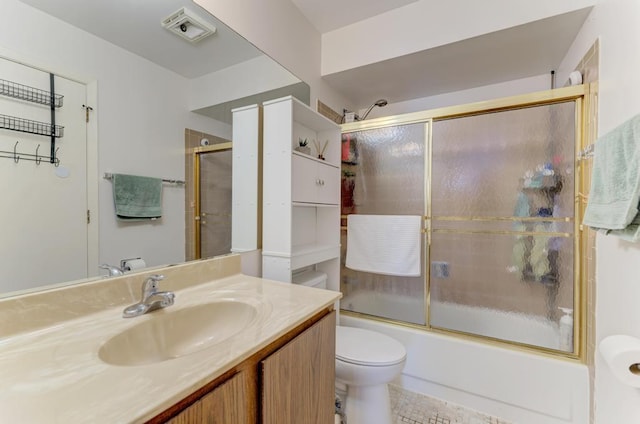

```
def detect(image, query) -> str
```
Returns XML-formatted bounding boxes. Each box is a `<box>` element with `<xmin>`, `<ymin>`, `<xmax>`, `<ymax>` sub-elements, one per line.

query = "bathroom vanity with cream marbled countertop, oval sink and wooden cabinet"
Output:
<box><xmin>0</xmin><ymin>256</ymin><xmax>340</xmax><ymax>424</ymax></box>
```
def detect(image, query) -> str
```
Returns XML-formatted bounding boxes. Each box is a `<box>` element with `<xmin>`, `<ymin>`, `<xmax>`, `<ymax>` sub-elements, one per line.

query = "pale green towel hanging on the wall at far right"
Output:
<box><xmin>583</xmin><ymin>115</ymin><xmax>640</xmax><ymax>241</ymax></box>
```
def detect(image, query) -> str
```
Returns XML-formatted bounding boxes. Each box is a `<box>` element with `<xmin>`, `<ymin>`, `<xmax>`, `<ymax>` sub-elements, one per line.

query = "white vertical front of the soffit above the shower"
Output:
<box><xmin>322</xmin><ymin>0</ymin><xmax>596</xmax><ymax>75</ymax></box>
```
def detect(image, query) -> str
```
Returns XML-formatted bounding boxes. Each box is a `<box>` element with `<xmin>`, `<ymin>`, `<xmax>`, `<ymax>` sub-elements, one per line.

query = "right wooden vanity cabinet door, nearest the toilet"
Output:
<box><xmin>261</xmin><ymin>311</ymin><xmax>336</xmax><ymax>424</ymax></box>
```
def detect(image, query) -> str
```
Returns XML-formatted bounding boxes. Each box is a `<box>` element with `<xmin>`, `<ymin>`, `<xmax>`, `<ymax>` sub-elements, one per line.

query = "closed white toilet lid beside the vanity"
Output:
<box><xmin>336</xmin><ymin>326</ymin><xmax>407</xmax><ymax>367</ymax></box>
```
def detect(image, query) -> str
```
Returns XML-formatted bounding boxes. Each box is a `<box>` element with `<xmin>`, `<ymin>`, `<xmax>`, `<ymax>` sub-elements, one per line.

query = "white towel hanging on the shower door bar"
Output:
<box><xmin>346</xmin><ymin>215</ymin><xmax>422</xmax><ymax>277</ymax></box>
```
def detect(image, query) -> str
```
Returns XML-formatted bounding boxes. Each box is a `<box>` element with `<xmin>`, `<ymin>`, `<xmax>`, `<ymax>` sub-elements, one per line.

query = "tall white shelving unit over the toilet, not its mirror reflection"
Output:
<box><xmin>262</xmin><ymin>96</ymin><xmax>341</xmax><ymax>290</ymax></box>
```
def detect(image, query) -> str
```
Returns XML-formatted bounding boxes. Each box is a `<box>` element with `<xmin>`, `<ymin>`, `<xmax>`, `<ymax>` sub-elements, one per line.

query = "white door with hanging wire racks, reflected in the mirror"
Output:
<box><xmin>0</xmin><ymin>59</ymin><xmax>88</xmax><ymax>293</ymax></box>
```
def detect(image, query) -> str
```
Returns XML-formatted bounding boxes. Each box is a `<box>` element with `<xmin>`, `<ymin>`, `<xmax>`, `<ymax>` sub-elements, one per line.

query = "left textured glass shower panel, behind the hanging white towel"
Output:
<box><xmin>340</xmin><ymin>122</ymin><xmax>428</xmax><ymax>325</ymax></box>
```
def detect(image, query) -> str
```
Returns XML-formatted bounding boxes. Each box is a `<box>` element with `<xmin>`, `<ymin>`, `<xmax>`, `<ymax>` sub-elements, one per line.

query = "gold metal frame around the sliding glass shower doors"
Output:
<box><xmin>340</xmin><ymin>85</ymin><xmax>591</xmax><ymax>362</ymax></box>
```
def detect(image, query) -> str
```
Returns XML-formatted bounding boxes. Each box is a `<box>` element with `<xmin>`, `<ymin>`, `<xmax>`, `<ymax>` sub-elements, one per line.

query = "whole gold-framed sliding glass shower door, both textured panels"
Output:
<box><xmin>341</xmin><ymin>87</ymin><xmax>584</xmax><ymax>357</ymax></box>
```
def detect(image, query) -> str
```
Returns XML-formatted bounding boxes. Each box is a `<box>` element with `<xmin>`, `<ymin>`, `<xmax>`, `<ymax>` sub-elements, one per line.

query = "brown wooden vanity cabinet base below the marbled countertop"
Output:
<box><xmin>161</xmin><ymin>312</ymin><xmax>336</xmax><ymax>424</ymax></box>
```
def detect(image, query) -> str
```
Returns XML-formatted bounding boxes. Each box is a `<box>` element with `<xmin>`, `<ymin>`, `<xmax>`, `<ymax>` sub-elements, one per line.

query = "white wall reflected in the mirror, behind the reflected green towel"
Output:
<box><xmin>0</xmin><ymin>0</ymin><xmax>231</xmax><ymax>274</ymax></box>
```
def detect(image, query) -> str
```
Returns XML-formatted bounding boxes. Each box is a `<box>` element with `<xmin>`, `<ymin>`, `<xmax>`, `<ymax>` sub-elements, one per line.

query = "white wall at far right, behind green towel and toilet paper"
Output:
<box><xmin>558</xmin><ymin>0</ymin><xmax>640</xmax><ymax>424</ymax></box>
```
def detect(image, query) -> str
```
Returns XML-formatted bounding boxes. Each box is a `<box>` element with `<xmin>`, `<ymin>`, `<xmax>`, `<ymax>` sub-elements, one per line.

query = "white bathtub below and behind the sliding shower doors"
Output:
<box><xmin>340</xmin><ymin>293</ymin><xmax>589</xmax><ymax>424</ymax></box>
